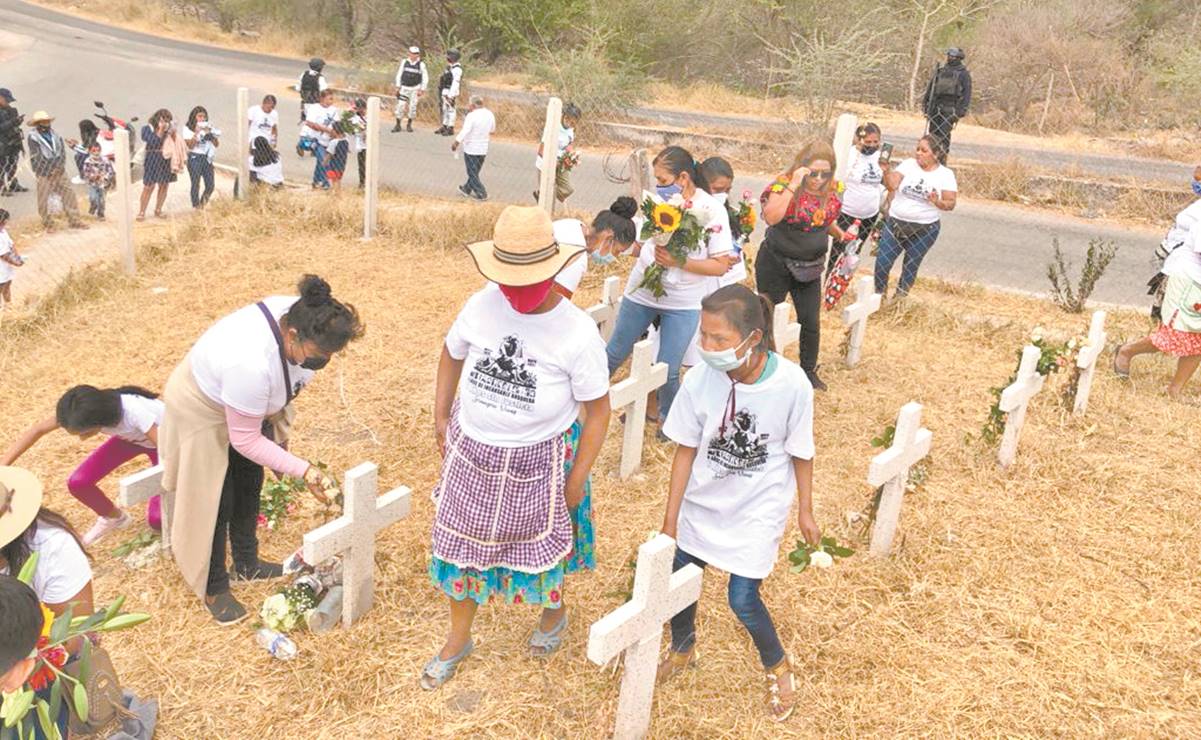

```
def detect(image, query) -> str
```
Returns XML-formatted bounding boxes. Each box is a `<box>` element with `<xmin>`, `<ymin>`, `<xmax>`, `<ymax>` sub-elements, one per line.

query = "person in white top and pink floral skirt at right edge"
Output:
<box><xmin>1113</xmin><ymin>227</ymin><xmax>1201</xmax><ymax>400</ymax></box>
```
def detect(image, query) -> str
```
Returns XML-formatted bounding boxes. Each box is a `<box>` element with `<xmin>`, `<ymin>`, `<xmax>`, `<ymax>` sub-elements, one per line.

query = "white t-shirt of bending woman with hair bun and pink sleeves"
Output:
<box><xmin>189</xmin><ymin>296</ymin><xmax>315</xmax><ymax>417</ymax></box>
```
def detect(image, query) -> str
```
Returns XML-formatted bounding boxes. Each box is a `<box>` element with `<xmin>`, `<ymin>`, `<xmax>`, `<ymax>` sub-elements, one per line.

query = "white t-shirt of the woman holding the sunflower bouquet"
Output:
<box><xmin>626</xmin><ymin>190</ymin><xmax>734</xmax><ymax>310</ymax></box>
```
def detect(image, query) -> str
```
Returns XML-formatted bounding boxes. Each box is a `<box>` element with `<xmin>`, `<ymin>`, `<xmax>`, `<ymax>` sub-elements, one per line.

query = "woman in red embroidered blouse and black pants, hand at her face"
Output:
<box><xmin>754</xmin><ymin>141</ymin><xmax>854</xmax><ymax>390</ymax></box>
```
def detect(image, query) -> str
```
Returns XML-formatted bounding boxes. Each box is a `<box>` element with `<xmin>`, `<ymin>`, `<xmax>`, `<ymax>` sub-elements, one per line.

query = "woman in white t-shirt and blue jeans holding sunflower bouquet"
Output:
<box><xmin>605</xmin><ymin>147</ymin><xmax>740</xmax><ymax>434</ymax></box>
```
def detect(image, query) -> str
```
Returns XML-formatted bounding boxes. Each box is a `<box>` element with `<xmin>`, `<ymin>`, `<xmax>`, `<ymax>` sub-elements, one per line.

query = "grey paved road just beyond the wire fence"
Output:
<box><xmin>0</xmin><ymin>0</ymin><xmax>1158</xmax><ymax>305</ymax></box>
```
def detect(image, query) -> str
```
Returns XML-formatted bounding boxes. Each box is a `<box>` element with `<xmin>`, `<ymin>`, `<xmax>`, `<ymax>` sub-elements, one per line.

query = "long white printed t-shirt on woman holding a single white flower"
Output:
<box><xmin>663</xmin><ymin>356</ymin><xmax>813</xmax><ymax>578</ymax></box>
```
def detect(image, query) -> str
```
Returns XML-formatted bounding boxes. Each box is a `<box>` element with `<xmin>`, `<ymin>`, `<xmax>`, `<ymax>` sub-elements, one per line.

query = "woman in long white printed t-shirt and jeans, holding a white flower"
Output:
<box><xmin>658</xmin><ymin>285</ymin><xmax>821</xmax><ymax>721</ymax></box>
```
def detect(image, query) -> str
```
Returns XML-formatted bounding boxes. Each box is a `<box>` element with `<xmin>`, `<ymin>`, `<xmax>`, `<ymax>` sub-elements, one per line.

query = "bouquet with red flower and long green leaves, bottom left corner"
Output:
<box><xmin>0</xmin><ymin>553</ymin><xmax>150</xmax><ymax>740</ymax></box>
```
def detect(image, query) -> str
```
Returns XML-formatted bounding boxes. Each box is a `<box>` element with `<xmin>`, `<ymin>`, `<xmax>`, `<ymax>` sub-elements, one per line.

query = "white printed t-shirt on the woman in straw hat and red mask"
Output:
<box><xmin>446</xmin><ymin>285</ymin><xmax>609</xmax><ymax>447</ymax></box>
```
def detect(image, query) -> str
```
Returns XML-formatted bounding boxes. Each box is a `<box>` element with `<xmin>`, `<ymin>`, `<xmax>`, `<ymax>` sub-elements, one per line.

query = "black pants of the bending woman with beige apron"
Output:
<box><xmin>205</xmin><ymin>447</ymin><xmax>263</xmax><ymax>596</ymax></box>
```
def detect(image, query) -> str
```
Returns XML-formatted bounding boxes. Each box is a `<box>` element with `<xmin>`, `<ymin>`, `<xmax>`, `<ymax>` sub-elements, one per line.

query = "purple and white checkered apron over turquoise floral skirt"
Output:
<box><xmin>434</xmin><ymin>408</ymin><xmax>572</xmax><ymax>573</ymax></box>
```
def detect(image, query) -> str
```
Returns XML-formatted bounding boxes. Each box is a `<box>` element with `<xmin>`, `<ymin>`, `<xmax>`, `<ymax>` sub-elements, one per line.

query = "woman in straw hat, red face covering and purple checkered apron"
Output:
<box><xmin>420</xmin><ymin>205</ymin><xmax>609</xmax><ymax>690</ymax></box>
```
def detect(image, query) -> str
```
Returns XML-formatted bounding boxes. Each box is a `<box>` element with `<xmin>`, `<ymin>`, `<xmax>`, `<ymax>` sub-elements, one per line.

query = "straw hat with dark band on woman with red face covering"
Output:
<box><xmin>467</xmin><ymin>205</ymin><xmax>584</xmax><ymax>287</ymax></box>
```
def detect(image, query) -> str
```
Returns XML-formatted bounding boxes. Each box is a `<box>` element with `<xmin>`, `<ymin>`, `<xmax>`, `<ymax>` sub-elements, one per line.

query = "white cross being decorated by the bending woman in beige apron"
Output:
<box><xmin>304</xmin><ymin>463</ymin><xmax>412</xmax><ymax>627</ymax></box>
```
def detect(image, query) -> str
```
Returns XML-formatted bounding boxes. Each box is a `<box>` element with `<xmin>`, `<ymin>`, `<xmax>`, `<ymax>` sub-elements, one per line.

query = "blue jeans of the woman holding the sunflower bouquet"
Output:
<box><xmin>604</xmin><ymin>298</ymin><xmax>700</xmax><ymax>424</ymax></box>
